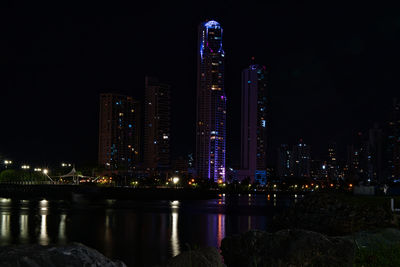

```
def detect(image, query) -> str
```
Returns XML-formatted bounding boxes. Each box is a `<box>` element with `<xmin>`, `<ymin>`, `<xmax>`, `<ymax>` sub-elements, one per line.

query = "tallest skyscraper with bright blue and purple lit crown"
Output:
<box><xmin>196</xmin><ymin>20</ymin><xmax>226</xmax><ymax>182</ymax></box>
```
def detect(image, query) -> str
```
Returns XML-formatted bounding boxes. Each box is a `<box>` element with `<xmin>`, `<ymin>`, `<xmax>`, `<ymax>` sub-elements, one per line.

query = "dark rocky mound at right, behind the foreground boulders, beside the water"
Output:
<box><xmin>272</xmin><ymin>193</ymin><xmax>398</xmax><ymax>236</ymax></box>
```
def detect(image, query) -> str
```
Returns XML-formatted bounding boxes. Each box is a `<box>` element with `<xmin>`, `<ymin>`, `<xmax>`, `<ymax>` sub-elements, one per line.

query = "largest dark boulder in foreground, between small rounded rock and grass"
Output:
<box><xmin>221</xmin><ymin>230</ymin><xmax>355</xmax><ymax>267</ymax></box>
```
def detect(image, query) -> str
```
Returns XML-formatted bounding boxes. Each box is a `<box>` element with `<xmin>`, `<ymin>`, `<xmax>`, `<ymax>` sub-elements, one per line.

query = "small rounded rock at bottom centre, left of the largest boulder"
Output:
<box><xmin>167</xmin><ymin>247</ymin><xmax>225</xmax><ymax>267</ymax></box>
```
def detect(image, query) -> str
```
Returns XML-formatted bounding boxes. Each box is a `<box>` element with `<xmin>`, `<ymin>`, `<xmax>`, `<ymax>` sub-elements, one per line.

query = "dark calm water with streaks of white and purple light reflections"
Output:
<box><xmin>0</xmin><ymin>194</ymin><xmax>296</xmax><ymax>266</ymax></box>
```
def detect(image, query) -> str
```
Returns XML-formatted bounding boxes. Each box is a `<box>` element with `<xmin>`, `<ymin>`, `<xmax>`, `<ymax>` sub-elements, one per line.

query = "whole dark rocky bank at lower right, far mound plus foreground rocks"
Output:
<box><xmin>167</xmin><ymin>193</ymin><xmax>400</xmax><ymax>267</ymax></box>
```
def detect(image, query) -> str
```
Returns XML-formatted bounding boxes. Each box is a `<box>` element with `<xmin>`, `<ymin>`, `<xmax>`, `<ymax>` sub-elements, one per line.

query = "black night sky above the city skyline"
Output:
<box><xmin>0</xmin><ymin>1</ymin><xmax>400</xmax><ymax>168</ymax></box>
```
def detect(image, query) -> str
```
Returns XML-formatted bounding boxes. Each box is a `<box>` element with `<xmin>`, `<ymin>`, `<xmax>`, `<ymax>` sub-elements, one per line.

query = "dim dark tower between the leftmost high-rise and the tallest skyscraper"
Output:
<box><xmin>144</xmin><ymin>76</ymin><xmax>171</xmax><ymax>177</ymax></box>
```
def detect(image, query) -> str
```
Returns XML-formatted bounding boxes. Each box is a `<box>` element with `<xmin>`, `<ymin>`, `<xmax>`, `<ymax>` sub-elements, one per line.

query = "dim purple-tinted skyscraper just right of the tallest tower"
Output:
<box><xmin>240</xmin><ymin>62</ymin><xmax>267</xmax><ymax>184</ymax></box>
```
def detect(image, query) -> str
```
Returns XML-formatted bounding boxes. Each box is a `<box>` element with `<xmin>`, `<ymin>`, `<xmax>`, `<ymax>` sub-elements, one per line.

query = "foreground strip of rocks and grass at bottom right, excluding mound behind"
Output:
<box><xmin>166</xmin><ymin>228</ymin><xmax>400</xmax><ymax>267</ymax></box>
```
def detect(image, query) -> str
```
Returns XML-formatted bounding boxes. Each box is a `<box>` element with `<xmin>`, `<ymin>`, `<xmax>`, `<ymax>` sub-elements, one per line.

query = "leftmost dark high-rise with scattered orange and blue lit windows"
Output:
<box><xmin>98</xmin><ymin>93</ymin><xmax>140</xmax><ymax>172</ymax></box>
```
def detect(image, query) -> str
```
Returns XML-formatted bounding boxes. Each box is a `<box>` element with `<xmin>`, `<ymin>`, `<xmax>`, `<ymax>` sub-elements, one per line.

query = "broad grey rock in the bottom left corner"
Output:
<box><xmin>0</xmin><ymin>243</ymin><xmax>126</xmax><ymax>267</ymax></box>
